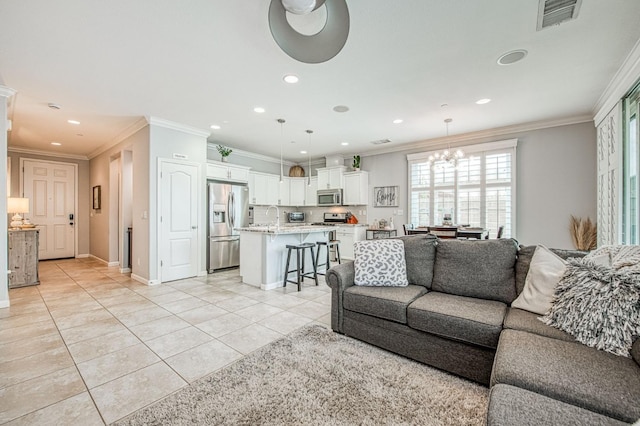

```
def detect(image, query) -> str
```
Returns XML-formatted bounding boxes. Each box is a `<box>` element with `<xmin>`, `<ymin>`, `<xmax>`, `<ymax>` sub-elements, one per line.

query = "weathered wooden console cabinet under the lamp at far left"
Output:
<box><xmin>8</xmin><ymin>229</ymin><xmax>40</xmax><ymax>288</ymax></box>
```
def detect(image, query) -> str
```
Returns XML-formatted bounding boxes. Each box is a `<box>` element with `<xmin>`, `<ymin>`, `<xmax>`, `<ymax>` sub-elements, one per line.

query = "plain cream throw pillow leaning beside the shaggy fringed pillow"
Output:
<box><xmin>511</xmin><ymin>245</ymin><xmax>566</xmax><ymax>315</ymax></box>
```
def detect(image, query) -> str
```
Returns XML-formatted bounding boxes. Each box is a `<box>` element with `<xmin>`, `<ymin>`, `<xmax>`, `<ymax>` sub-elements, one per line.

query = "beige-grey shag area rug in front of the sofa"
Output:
<box><xmin>115</xmin><ymin>325</ymin><xmax>489</xmax><ymax>425</ymax></box>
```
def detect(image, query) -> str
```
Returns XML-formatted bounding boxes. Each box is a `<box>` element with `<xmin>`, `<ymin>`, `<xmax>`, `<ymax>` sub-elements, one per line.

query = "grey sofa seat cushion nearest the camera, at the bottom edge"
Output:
<box><xmin>487</xmin><ymin>384</ymin><xmax>627</xmax><ymax>426</ymax></box>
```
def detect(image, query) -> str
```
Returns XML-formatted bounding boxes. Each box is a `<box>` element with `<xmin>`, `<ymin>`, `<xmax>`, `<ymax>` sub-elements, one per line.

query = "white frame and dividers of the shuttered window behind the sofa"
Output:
<box><xmin>407</xmin><ymin>139</ymin><xmax>518</xmax><ymax>238</ymax></box>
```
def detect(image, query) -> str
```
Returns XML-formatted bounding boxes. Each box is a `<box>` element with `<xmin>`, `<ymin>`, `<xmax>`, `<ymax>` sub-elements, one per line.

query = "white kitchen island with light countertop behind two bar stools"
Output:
<box><xmin>237</xmin><ymin>225</ymin><xmax>335</xmax><ymax>290</ymax></box>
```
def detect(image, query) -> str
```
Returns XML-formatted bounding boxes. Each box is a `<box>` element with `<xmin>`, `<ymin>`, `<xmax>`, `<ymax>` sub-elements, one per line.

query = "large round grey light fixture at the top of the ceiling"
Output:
<box><xmin>269</xmin><ymin>0</ymin><xmax>350</xmax><ymax>64</ymax></box>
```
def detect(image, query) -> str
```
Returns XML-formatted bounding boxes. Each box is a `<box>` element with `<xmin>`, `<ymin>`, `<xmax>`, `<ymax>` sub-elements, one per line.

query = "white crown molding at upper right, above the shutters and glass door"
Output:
<box><xmin>593</xmin><ymin>40</ymin><xmax>640</xmax><ymax>125</ymax></box>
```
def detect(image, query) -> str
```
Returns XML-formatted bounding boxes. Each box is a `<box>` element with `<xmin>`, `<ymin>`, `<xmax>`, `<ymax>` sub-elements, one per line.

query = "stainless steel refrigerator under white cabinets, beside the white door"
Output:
<box><xmin>207</xmin><ymin>182</ymin><xmax>249</xmax><ymax>273</ymax></box>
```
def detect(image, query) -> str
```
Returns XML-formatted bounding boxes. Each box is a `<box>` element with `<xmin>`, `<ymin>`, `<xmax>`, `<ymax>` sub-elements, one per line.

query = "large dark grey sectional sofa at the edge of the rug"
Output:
<box><xmin>326</xmin><ymin>235</ymin><xmax>640</xmax><ymax>425</ymax></box>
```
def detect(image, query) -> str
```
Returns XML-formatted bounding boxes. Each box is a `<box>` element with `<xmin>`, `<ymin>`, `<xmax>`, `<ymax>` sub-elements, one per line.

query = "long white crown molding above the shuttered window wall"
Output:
<box><xmin>360</xmin><ymin>114</ymin><xmax>593</xmax><ymax>157</ymax></box>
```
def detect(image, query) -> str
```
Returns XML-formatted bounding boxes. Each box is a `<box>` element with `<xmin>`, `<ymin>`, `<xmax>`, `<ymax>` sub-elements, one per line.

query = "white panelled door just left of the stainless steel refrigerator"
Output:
<box><xmin>159</xmin><ymin>162</ymin><xmax>199</xmax><ymax>282</ymax></box>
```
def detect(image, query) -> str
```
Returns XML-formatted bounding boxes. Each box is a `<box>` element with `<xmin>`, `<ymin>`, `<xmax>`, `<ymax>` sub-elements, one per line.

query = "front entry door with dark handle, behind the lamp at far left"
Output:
<box><xmin>23</xmin><ymin>160</ymin><xmax>76</xmax><ymax>259</ymax></box>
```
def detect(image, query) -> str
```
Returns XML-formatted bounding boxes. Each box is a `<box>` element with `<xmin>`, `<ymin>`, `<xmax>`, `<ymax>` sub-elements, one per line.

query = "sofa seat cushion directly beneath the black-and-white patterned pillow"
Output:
<box><xmin>343</xmin><ymin>285</ymin><xmax>427</xmax><ymax>324</ymax></box>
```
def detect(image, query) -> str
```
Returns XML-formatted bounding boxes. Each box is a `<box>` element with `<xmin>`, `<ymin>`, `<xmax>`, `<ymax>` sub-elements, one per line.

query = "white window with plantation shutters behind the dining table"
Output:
<box><xmin>407</xmin><ymin>139</ymin><xmax>517</xmax><ymax>238</ymax></box>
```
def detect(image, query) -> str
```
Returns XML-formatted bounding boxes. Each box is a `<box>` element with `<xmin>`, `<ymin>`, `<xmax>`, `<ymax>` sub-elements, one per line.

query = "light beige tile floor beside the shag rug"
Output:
<box><xmin>0</xmin><ymin>259</ymin><xmax>331</xmax><ymax>426</ymax></box>
